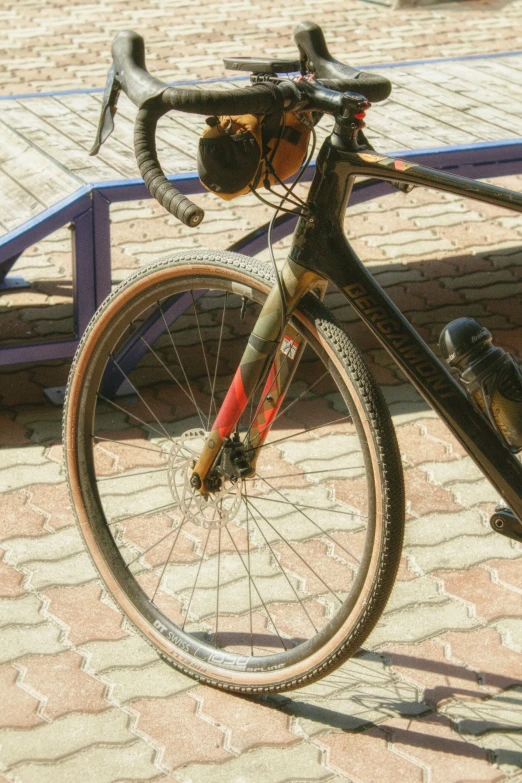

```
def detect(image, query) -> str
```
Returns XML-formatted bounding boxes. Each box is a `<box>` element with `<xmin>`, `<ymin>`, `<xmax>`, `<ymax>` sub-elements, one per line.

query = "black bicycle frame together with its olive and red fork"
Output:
<box><xmin>195</xmin><ymin>135</ymin><xmax>522</xmax><ymax>521</ymax></box>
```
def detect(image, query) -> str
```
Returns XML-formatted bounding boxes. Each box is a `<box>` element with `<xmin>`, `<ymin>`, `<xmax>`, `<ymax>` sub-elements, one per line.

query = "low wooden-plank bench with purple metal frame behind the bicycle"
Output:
<box><xmin>0</xmin><ymin>52</ymin><xmax>522</xmax><ymax>365</ymax></box>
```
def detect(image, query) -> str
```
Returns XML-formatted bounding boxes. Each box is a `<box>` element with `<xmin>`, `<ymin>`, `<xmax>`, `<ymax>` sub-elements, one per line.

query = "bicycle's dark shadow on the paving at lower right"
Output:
<box><xmin>247</xmin><ymin>650</ymin><xmax>522</xmax><ymax>768</ymax></box>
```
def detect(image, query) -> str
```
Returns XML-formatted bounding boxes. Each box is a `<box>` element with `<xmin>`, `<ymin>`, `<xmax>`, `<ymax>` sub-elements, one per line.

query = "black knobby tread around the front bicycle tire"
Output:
<box><xmin>62</xmin><ymin>250</ymin><xmax>404</xmax><ymax>695</ymax></box>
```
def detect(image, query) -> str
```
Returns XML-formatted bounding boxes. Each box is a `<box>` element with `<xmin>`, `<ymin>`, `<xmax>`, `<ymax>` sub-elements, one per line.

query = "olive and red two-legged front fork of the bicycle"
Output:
<box><xmin>189</xmin><ymin>259</ymin><xmax>326</xmax><ymax>491</ymax></box>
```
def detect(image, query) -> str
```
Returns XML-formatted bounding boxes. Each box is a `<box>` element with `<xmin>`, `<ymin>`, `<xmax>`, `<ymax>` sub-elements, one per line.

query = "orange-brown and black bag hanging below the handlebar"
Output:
<box><xmin>198</xmin><ymin>112</ymin><xmax>313</xmax><ymax>201</ymax></box>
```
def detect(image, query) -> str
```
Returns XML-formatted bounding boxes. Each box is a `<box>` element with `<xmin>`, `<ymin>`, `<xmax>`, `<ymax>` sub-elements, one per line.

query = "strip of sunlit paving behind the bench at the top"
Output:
<box><xmin>0</xmin><ymin>0</ymin><xmax>522</xmax><ymax>94</ymax></box>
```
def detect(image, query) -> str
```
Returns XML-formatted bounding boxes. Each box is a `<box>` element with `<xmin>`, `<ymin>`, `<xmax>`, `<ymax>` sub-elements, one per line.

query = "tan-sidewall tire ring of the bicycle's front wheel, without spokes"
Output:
<box><xmin>64</xmin><ymin>251</ymin><xmax>404</xmax><ymax>693</ymax></box>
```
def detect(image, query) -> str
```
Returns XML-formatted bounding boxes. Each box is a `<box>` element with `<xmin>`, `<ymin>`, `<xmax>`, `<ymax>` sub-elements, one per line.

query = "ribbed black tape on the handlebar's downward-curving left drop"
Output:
<box><xmin>134</xmin><ymin>100</ymin><xmax>205</xmax><ymax>227</ymax></box>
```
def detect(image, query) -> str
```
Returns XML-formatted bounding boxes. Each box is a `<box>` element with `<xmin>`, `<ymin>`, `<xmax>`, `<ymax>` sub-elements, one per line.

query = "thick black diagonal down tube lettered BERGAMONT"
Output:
<box><xmin>316</xmin><ymin>235</ymin><xmax>522</xmax><ymax>520</ymax></box>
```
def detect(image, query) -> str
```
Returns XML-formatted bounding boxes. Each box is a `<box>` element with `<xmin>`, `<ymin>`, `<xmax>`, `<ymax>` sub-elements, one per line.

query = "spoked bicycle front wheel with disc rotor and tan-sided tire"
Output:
<box><xmin>64</xmin><ymin>251</ymin><xmax>404</xmax><ymax>693</ymax></box>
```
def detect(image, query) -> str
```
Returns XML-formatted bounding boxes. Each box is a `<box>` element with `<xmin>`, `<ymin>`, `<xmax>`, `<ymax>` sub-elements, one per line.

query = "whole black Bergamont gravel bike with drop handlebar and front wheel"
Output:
<box><xmin>64</xmin><ymin>23</ymin><xmax>522</xmax><ymax>694</ymax></box>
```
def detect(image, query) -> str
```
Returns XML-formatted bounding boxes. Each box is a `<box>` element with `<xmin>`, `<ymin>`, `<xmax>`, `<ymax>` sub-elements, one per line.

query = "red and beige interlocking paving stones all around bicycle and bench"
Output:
<box><xmin>0</xmin><ymin>0</ymin><xmax>522</xmax><ymax>783</ymax></box>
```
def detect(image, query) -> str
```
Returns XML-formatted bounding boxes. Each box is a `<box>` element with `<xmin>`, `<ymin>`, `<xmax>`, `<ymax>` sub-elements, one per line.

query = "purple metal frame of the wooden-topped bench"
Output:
<box><xmin>0</xmin><ymin>46</ymin><xmax>522</xmax><ymax>366</ymax></box>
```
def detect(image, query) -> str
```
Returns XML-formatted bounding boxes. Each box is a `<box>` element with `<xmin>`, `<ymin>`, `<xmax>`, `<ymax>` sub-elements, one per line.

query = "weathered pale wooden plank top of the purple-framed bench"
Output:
<box><xmin>0</xmin><ymin>55</ymin><xmax>522</xmax><ymax>234</ymax></box>
